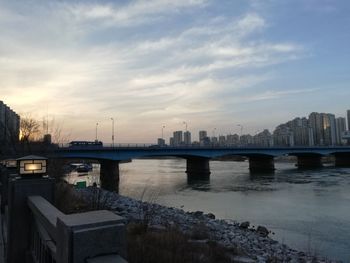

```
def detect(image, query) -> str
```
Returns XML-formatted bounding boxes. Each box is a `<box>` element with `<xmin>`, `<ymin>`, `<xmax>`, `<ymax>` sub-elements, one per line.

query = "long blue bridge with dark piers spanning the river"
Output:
<box><xmin>52</xmin><ymin>146</ymin><xmax>350</xmax><ymax>190</ymax></box>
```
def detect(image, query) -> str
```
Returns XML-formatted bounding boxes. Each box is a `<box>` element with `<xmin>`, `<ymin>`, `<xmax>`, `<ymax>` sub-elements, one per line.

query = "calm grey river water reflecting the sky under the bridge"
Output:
<box><xmin>67</xmin><ymin>159</ymin><xmax>350</xmax><ymax>262</ymax></box>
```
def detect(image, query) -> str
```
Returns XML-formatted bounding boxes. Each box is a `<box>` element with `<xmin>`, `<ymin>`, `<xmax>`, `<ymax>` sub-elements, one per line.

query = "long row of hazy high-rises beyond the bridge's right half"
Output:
<box><xmin>164</xmin><ymin>110</ymin><xmax>350</xmax><ymax>147</ymax></box>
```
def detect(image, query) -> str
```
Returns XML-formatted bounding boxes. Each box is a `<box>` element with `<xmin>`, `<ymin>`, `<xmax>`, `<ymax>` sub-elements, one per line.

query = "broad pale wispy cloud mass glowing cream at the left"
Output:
<box><xmin>0</xmin><ymin>0</ymin><xmax>304</xmax><ymax>140</ymax></box>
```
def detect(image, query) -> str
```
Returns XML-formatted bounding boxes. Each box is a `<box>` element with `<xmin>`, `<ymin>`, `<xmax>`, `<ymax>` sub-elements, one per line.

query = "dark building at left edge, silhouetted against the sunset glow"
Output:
<box><xmin>0</xmin><ymin>101</ymin><xmax>20</xmax><ymax>145</ymax></box>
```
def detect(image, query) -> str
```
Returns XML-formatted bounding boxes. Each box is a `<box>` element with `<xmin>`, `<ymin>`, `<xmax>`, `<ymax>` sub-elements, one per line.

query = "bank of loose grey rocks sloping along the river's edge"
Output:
<box><xmin>79</xmin><ymin>187</ymin><xmax>339</xmax><ymax>263</ymax></box>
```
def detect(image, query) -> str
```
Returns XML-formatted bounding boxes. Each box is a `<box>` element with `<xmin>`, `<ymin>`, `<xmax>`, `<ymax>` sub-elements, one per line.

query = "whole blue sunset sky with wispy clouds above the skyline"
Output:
<box><xmin>0</xmin><ymin>0</ymin><xmax>350</xmax><ymax>143</ymax></box>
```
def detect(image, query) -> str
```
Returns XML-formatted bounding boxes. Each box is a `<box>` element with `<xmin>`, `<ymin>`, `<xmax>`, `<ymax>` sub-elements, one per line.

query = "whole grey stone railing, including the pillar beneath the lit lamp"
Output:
<box><xmin>0</xmin><ymin>165</ymin><xmax>126</xmax><ymax>263</ymax></box>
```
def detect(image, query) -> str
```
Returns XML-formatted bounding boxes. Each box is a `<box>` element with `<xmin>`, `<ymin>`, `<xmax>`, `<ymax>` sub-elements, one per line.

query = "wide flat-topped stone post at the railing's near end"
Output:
<box><xmin>56</xmin><ymin>210</ymin><xmax>126</xmax><ymax>263</ymax></box>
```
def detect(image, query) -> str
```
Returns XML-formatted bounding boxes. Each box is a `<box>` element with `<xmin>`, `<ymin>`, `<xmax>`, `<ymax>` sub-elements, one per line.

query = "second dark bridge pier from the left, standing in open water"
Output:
<box><xmin>186</xmin><ymin>157</ymin><xmax>210</xmax><ymax>181</ymax></box>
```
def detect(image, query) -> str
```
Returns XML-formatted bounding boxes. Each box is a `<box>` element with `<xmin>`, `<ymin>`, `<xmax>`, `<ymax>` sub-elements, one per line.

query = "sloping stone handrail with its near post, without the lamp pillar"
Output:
<box><xmin>28</xmin><ymin>196</ymin><xmax>126</xmax><ymax>263</ymax></box>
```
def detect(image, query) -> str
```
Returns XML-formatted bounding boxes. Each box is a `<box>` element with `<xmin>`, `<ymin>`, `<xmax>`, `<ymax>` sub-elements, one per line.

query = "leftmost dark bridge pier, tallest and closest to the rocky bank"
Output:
<box><xmin>99</xmin><ymin>160</ymin><xmax>119</xmax><ymax>191</ymax></box>
